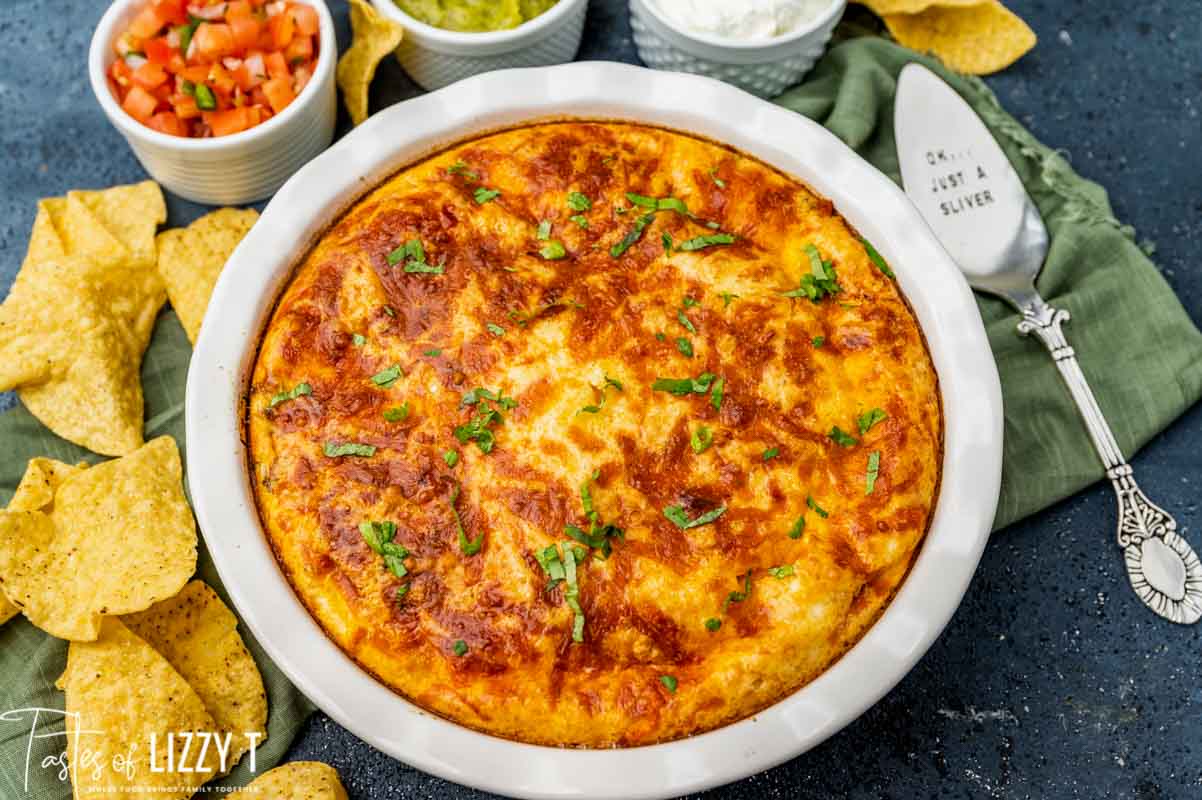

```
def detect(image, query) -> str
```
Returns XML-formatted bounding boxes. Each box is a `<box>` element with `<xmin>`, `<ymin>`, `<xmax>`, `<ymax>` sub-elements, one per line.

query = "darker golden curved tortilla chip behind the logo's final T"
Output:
<box><xmin>121</xmin><ymin>580</ymin><xmax>267</xmax><ymax>769</ymax></box>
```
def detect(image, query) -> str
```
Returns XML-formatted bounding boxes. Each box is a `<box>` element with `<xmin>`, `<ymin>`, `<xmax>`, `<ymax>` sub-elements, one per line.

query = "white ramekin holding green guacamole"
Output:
<box><xmin>371</xmin><ymin>0</ymin><xmax>589</xmax><ymax>91</ymax></box>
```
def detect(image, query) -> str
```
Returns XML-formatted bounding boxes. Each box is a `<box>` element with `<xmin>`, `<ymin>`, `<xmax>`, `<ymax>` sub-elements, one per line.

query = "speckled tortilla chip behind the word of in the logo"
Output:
<box><xmin>58</xmin><ymin>617</ymin><xmax>219</xmax><ymax>800</ymax></box>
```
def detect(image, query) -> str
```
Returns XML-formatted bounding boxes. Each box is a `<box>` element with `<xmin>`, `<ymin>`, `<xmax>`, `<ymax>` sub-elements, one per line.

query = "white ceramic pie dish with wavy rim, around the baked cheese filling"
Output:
<box><xmin>186</xmin><ymin>64</ymin><xmax>1002</xmax><ymax>798</ymax></box>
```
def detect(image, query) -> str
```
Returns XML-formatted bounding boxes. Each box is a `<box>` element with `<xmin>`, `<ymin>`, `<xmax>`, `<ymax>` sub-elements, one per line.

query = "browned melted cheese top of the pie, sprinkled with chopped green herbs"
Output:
<box><xmin>248</xmin><ymin>123</ymin><xmax>941</xmax><ymax>746</ymax></box>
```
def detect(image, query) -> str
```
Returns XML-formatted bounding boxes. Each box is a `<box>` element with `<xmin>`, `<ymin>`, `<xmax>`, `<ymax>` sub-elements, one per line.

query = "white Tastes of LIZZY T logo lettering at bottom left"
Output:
<box><xmin>0</xmin><ymin>708</ymin><xmax>263</xmax><ymax>794</ymax></box>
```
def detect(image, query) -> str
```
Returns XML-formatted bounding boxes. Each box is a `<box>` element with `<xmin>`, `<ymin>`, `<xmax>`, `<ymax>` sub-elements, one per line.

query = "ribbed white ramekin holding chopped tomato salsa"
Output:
<box><xmin>88</xmin><ymin>0</ymin><xmax>338</xmax><ymax>205</ymax></box>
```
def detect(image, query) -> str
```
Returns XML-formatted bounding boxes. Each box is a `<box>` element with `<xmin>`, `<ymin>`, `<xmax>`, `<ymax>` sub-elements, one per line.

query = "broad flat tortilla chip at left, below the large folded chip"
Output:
<box><xmin>0</xmin><ymin>436</ymin><xmax>196</xmax><ymax>641</ymax></box>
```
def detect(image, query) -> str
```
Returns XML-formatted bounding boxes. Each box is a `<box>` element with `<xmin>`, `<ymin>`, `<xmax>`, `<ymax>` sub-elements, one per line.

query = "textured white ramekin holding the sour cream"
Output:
<box><xmin>630</xmin><ymin>0</ymin><xmax>847</xmax><ymax>97</ymax></box>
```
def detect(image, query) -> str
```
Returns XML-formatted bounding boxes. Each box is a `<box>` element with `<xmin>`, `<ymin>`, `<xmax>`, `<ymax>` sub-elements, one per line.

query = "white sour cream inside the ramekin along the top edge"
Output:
<box><xmin>649</xmin><ymin>0</ymin><xmax>832</xmax><ymax>41</ymax></box>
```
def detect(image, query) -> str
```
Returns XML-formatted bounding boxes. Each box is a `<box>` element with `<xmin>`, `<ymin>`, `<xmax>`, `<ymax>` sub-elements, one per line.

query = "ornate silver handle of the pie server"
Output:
<box><xmin>1018</xmin><ymin>297</ymin><xmax>1202</xmax><ymax>625</ymax></box>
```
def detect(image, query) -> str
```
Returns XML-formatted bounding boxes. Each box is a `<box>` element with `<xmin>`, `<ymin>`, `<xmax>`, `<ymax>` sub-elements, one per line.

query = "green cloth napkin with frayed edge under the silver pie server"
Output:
<box><xmin>776</xmin><ymin>38</ymin><xmax>1202</xmax><ymax>530</ymax></box>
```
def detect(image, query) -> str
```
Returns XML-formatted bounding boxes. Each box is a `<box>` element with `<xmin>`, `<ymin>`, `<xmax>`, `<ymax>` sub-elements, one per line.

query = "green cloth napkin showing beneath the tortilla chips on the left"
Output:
<box><xmin>0</xmin><ymin>311</ymin><xmax>314</xmax><ymax>800</ymax></box>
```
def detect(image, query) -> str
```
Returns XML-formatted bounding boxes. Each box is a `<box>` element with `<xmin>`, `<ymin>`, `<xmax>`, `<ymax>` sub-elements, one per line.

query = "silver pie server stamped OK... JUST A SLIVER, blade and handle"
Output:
<box><xmin>894</xmin><ymin>64</ymin><xmax>1202</xmax><ymax>623</ymax></box>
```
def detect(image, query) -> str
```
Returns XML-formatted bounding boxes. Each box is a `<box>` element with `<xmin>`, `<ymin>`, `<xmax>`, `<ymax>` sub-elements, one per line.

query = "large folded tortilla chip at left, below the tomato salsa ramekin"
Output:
<box><xmin>0</xmin><ymin>181</ymin><xmax>167</xmax><ymax>455</ymax></box>
